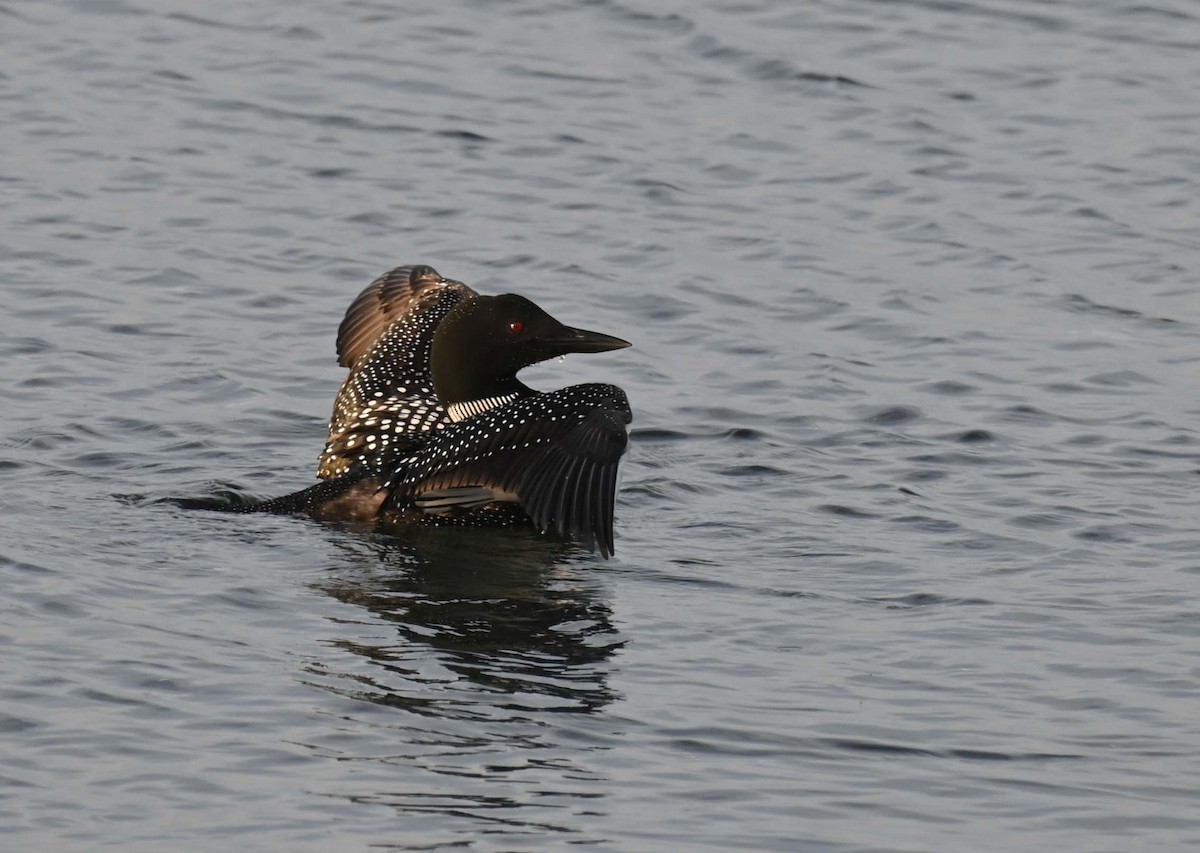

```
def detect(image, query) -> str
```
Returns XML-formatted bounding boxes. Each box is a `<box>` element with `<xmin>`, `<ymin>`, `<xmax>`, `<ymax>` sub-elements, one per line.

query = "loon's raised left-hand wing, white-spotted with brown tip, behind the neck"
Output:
<box><xmin>317</xmin><ymin>266</ymin><xmax>474</xmax><ymax>479</ymax></box>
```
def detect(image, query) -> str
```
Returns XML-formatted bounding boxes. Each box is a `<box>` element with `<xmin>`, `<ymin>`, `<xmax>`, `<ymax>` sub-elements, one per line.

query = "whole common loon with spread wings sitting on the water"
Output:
<box><xmin>234</xmin><ymin>265</ymin><xmax>632</xmax><ymax>557</ymax></box>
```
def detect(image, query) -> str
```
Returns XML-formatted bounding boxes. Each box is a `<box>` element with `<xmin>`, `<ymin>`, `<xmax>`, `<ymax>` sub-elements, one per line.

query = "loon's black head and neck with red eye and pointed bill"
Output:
<box><xmin>430</xmin><ymin>293</ymin><xmax>630</xmax><ymax>407</ymax></box>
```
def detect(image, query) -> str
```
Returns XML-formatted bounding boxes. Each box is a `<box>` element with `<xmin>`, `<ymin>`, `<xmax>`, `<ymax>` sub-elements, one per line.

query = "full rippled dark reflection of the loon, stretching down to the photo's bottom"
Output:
<box><xmin>302</xmin><ymin>525</ymin><xmax>622</xmax><ymax>849</ymax></box>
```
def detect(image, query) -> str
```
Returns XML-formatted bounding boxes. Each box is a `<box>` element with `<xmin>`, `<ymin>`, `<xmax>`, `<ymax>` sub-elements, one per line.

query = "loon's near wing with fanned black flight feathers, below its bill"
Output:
<box><xmin>383</xmin><ymin>384</ymin><xmax>631</xmax><ymax>557</ymax></box>
